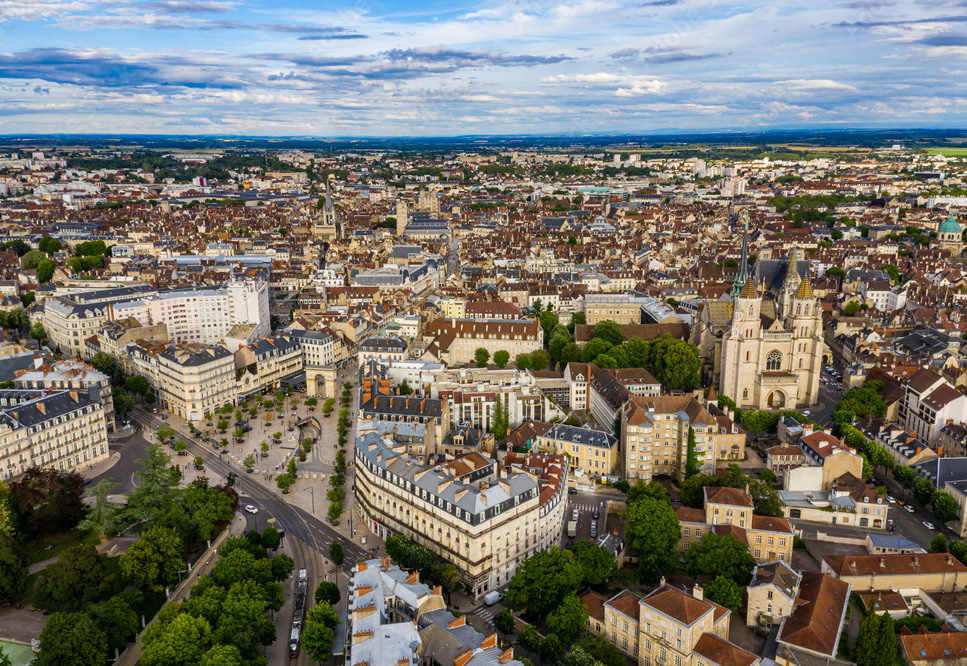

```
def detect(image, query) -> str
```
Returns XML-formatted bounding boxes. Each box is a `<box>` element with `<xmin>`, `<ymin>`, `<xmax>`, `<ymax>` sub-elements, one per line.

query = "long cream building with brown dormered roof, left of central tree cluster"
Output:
<box><xmin>422</xmin><ymin>318</ymin><xmax>544</xmax><ymax>365</ymax></box>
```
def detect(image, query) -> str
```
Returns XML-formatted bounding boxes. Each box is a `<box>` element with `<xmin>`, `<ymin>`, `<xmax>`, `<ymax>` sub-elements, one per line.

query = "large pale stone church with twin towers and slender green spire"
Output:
<box><xmin>693</xmin><ymin>221</ymin><xmax>826</xmax><ymax>410</ymax></box>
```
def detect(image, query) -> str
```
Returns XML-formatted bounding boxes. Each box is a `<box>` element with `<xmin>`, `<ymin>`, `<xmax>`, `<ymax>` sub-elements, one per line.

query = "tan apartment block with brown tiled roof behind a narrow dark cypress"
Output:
<box><xmin>621</xmin><ymin>396</ymin><xmax>745</xmax><ymax>483</ymax></box>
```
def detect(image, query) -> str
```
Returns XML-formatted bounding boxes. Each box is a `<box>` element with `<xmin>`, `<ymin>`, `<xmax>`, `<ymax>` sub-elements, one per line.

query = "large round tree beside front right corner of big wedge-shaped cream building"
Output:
<box><xmin>506</xmin><ymin>546</ymin><xmax>583</xmax><ymax>616</ymax></box>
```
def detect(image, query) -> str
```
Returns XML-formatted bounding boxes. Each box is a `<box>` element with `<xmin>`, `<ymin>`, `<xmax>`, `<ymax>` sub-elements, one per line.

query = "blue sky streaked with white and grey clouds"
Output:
<box><xmin>0</xmin><ymin>0</ymin><xmax>967</xmax><ymax>138</ymax></box>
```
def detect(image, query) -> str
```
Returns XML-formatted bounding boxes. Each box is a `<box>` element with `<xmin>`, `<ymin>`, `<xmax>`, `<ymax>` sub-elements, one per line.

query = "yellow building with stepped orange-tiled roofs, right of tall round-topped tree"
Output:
<box><xmin>675</xmin><ymin>486</ymin><xmax>795</xmax><ymax>562</ymax></box>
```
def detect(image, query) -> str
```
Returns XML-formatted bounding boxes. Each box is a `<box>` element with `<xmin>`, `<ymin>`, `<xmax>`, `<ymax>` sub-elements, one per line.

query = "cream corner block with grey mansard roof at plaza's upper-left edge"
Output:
<box><xmin>158</xmin><ymin>344</ymin><xmax>238</xmax><ymax>422</ymax></box>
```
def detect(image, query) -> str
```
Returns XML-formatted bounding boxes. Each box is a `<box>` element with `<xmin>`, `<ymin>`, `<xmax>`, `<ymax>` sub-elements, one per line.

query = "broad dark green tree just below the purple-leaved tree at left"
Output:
<box><xmin>34</xmin><ymin>545</ymin><xmax>110</xmax><ymax>613</ymax></box>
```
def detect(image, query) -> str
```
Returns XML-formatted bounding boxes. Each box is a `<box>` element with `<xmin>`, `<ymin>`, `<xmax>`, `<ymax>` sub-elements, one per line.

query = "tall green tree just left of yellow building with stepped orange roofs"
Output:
<box><xmin>625</xmin><ymin>497</ymin><xmax>682</xmax><ymax>584</ymax></box>
